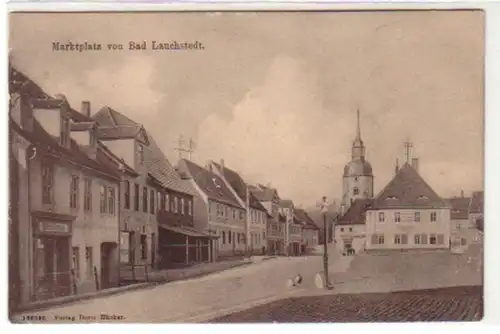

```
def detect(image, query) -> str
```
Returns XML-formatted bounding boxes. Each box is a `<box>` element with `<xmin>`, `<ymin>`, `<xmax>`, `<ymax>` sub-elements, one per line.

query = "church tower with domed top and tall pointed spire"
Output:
<box><xmin>341</xmin><ymin>109</ymin><xmax>373</xmax><ymax>214</ymax></box>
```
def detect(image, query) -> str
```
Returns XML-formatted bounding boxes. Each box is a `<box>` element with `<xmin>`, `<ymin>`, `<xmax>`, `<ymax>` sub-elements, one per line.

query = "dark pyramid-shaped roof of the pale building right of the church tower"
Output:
<box><xmin>372</xmin><ymin>163</ymin><xmax>449</xmax><ymax>209</ymax></box>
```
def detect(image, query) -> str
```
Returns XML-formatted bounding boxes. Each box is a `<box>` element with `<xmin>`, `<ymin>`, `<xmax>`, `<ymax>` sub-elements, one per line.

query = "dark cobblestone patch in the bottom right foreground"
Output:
<box><xmin>209</xmin><ymin>286</ymin><xmax>483</xmax><ymax>323</ymax></box>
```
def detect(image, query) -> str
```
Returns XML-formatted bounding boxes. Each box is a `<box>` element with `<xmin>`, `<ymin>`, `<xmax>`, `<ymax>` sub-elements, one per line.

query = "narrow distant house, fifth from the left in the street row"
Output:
<box><xmin>249</xmin><ymin>184</ymin><xmax>286</xmax><ymax>255</ymax></box>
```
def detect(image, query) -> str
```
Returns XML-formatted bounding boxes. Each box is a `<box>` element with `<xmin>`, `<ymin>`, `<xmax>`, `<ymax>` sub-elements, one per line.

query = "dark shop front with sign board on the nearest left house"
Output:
<box><xmin>32</xmin><ymin>217</ymin><xmax>73</xmax><ymax>301</ymax></box>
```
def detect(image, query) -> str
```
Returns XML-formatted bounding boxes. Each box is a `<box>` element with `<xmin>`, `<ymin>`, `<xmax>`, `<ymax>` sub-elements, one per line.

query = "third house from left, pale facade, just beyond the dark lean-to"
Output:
<box><xmin>177</xmin><ymin>159</ymin><xmax>247</xmax><ymax>259</ymax></box>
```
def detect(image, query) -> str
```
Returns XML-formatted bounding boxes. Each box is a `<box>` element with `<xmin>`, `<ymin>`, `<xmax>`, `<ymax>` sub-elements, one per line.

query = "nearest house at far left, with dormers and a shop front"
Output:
<box><xmin>9</xmin><ymin>68</ymin><xmax>122</xmax><ymax>307</ymax></box>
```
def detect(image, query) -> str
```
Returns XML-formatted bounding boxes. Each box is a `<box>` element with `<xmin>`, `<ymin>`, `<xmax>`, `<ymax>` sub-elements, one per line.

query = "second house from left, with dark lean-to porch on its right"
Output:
<box><xmin>93</xmin><ymin>107</ymin><xmax>210</xmax><ymax>268</ymax></box>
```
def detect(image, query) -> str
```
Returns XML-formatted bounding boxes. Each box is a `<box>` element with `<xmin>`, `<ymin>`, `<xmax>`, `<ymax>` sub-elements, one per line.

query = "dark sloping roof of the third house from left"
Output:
<box><xmin>178</xmin><ymin>159</ymin><xmax>243</xmax><ymax>208</ymax></box>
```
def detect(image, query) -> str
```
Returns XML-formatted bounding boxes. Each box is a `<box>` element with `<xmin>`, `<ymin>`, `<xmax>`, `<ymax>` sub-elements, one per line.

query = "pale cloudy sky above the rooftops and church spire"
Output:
<box><xmin>9</xmin><ymin>11</ymin><xmax>484</xmax><ymax>206</ymax></box>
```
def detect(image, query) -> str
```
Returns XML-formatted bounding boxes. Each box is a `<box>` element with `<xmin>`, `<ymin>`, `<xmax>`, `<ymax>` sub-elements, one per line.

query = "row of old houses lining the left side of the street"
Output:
<box><xmin>9</xmin><ymin>66</ymin><xmax>318</xmax><ymax>308</ymax></box>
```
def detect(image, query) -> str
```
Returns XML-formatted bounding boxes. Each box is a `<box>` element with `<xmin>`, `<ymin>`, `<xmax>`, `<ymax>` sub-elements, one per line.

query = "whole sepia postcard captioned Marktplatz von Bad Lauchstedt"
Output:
<box><xmin>8</xmin><ymin>10</ymin><xmax>485</xmax><ymax>324</ymax></box>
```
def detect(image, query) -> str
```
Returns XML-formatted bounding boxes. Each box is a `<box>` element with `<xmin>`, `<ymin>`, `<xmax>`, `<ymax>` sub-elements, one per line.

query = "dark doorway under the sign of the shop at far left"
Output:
<box><xmin>34</xmin><ymin>236</ymin><xmax>71</xmax><ymax>300</ymax></box>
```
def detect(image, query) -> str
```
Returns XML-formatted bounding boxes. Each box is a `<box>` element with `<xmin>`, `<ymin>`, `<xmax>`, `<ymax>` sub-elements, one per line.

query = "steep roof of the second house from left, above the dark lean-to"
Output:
<box><xmin>92</xmin><ymin>107</ymin><xmax>194</xmax><ymax>195</ymax></box>
